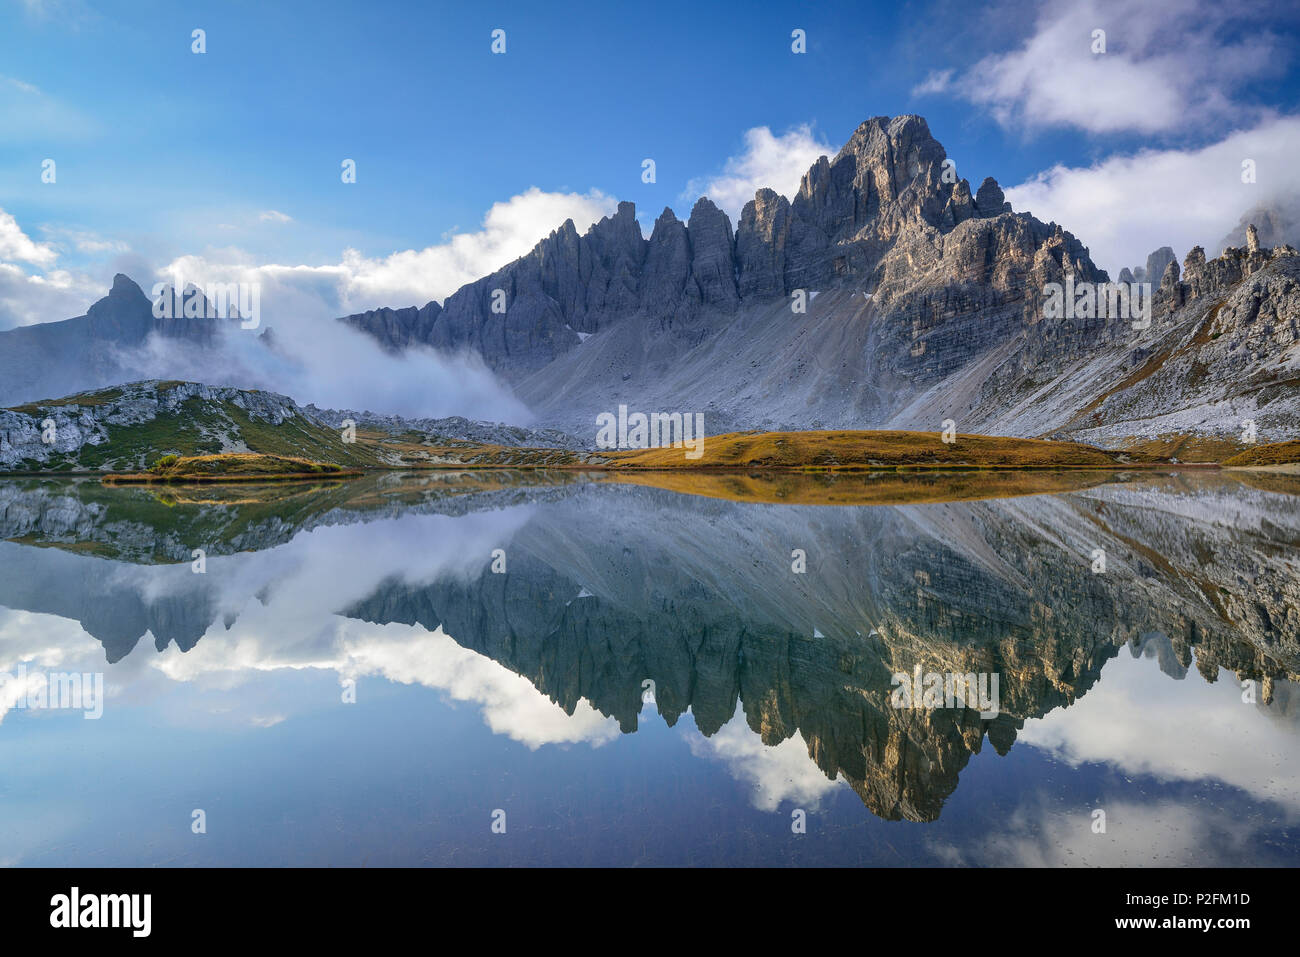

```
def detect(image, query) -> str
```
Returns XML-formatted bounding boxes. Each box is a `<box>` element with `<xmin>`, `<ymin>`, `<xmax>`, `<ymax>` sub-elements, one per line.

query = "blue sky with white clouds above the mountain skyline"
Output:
<box><xmin>0</xmin><ymin>0</ymin><xmax>1300</xmax><ymax>328</ymax></box>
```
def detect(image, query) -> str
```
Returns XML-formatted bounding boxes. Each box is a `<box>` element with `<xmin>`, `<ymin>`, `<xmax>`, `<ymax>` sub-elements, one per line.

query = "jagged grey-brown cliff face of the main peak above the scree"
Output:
<box><xmin>347</xmin><ymin>116</ymin><xmax>1101</xmax><ymax>395</ymax></box>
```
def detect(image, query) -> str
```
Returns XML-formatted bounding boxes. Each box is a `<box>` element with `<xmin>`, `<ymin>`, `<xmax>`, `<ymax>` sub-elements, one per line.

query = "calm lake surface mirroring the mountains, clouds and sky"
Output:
<box><xmin>0</xmin><ymin>472</ymin><xmax>1300</xmax><ymax>866</ymax></box>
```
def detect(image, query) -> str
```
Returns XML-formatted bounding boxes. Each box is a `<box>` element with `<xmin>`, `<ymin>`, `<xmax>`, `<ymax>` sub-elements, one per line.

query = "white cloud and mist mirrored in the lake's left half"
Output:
<box><xmin>0</xmin><ymin>507</ymin><xmax>620</xmax><ymax>750</ymax></box>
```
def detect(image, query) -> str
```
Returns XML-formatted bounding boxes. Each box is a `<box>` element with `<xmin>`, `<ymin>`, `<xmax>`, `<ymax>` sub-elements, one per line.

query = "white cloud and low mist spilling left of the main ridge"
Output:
<box><xmin>100</xmin><ymin>187</ymin><xmax>616</xmax><ymax>424</ymax></box>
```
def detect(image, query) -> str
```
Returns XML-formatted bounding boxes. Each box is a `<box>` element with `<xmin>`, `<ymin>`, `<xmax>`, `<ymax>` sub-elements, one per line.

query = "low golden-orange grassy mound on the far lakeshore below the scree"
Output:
<box><xmin>603</xmin><ymin>430</ymin><xmax>1121</xmax><ymax>471</ymax></box>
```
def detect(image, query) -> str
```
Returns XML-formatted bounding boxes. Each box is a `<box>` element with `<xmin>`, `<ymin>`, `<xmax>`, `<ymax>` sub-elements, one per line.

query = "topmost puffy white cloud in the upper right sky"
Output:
<box><xmin>913</xmin><ymin>0</ymin><xmax>1283</xmax><ymax>133</ymax></box>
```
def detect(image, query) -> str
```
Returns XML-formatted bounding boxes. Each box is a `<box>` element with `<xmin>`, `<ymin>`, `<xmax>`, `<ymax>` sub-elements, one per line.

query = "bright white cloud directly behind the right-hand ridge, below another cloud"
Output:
<box><xmin>1006</xmin><ymin>117</ymin><xmax>1300</xmax><ymax>278</ymax></box>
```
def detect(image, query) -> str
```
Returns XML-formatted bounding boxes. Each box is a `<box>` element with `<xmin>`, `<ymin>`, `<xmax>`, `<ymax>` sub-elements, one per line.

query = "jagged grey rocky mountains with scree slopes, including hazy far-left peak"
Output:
<box><xmin>0</xmin><ymin>116</ymin><xmax>1300</xmax><ymax>449</ymax></box>
